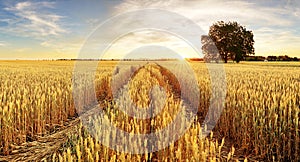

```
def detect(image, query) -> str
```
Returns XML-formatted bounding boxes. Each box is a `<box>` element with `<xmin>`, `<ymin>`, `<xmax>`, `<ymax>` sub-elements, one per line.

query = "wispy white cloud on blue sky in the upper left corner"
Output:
<box><xmin>2</xmin><ymin>1</ymin><xmax>67</xmax><ymax>38</ymax></box>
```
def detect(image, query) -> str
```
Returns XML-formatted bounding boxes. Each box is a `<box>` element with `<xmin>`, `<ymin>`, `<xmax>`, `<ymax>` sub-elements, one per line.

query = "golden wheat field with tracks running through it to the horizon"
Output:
<box><xmin>0</xmin><ymin>61</ymin><xmax>300</xmax><ymax>162</ymax></box>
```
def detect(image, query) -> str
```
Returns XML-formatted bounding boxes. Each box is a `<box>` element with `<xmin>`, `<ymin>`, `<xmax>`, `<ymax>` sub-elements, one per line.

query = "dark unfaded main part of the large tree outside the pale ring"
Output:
<box><xmin>208</xmin><ymin>21</ymin><xmax>254</xmax><ymax>63</ymax></box>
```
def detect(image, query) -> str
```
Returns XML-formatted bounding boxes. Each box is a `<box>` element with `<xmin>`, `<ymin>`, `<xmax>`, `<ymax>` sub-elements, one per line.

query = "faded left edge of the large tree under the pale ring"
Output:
<box><xmin>201</xmin><ymin>35</ymin><xmax>219</xmax><ymax>62</ymax></box>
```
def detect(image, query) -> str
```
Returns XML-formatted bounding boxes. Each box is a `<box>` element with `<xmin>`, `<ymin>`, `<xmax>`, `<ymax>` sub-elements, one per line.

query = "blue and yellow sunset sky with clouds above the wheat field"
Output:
<box><xmin>0</xmin><ymin>0</ymin><xmax>300</xmax><ymax>59</ymax></box>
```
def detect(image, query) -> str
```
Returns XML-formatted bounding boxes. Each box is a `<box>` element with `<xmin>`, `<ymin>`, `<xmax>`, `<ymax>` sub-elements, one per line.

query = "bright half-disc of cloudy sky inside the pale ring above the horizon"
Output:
<box><xmin>98</xmin><ymin>31</ymin><xmax>202</xmax><ymax>58</ymax></box>
